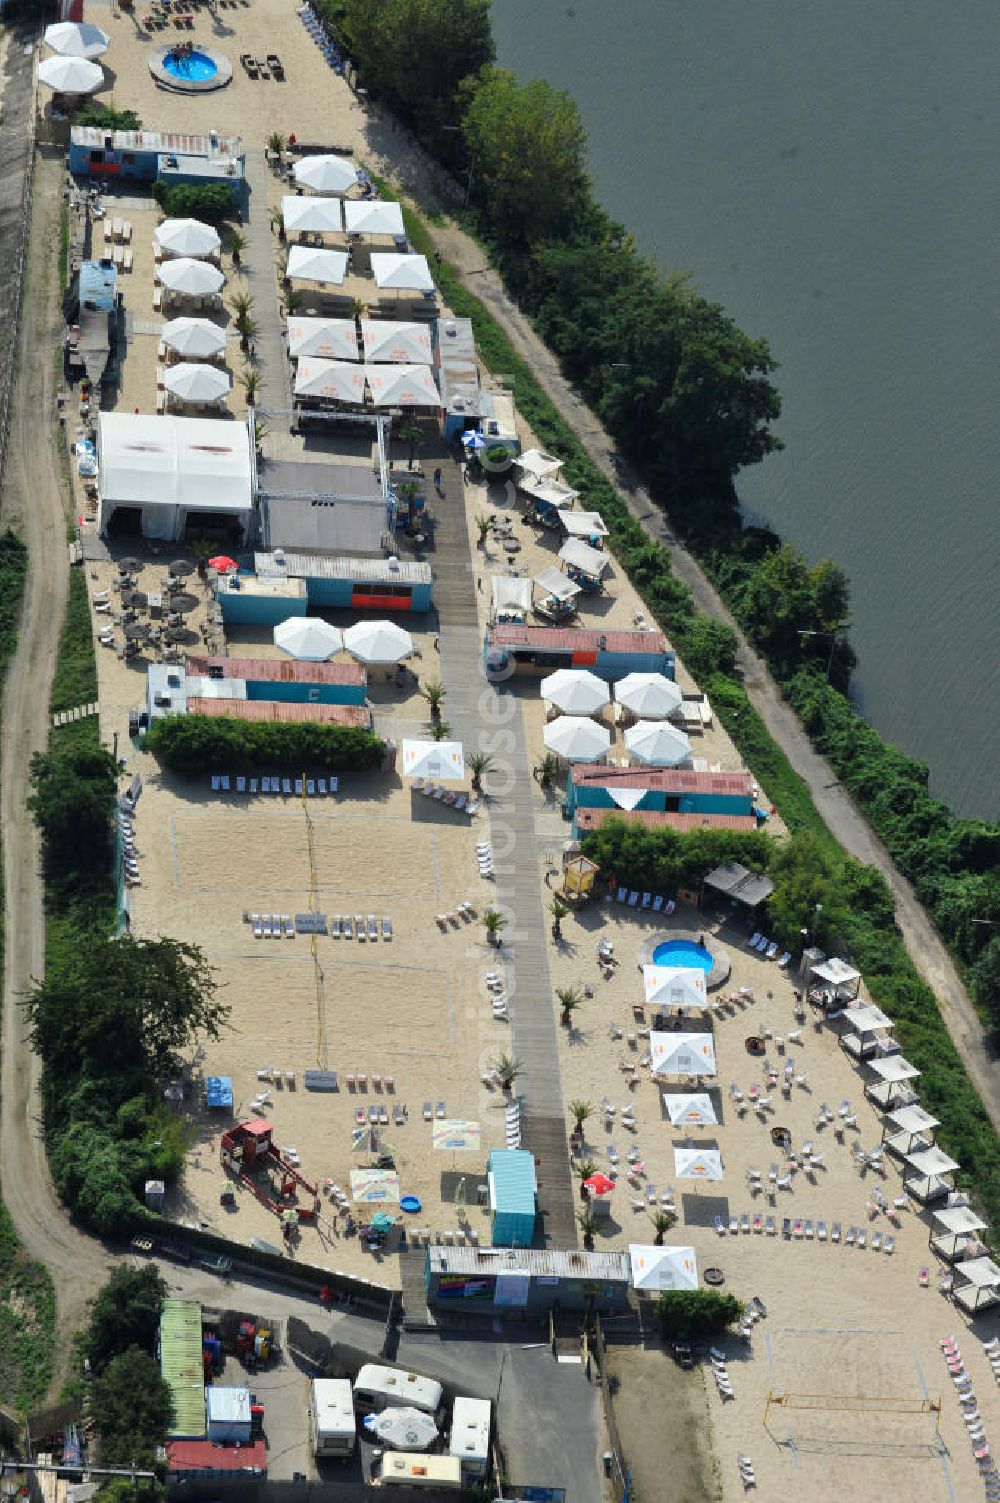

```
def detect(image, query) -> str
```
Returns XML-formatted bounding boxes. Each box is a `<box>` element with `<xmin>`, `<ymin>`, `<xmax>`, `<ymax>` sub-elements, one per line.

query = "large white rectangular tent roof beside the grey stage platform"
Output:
<box><xmin>98</xmin><ymin>412</ymin><xmax>251</xmax><ymax>513</ymax></box>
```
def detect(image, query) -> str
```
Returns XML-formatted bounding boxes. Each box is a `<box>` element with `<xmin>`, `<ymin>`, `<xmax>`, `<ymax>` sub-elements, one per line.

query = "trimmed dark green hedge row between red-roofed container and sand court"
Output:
<box><xmin>144</xmin><ymin>715</ymin><xmax>385</xmax><ymax>777</ymax></box>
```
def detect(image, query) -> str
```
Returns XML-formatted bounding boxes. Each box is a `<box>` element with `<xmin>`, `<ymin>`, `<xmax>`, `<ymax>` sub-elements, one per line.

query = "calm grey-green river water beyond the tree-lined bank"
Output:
<box><xmin>493</xmin><ymin>0</ymin><xmax>1000</xmax><ymax>818</ymax></box>
